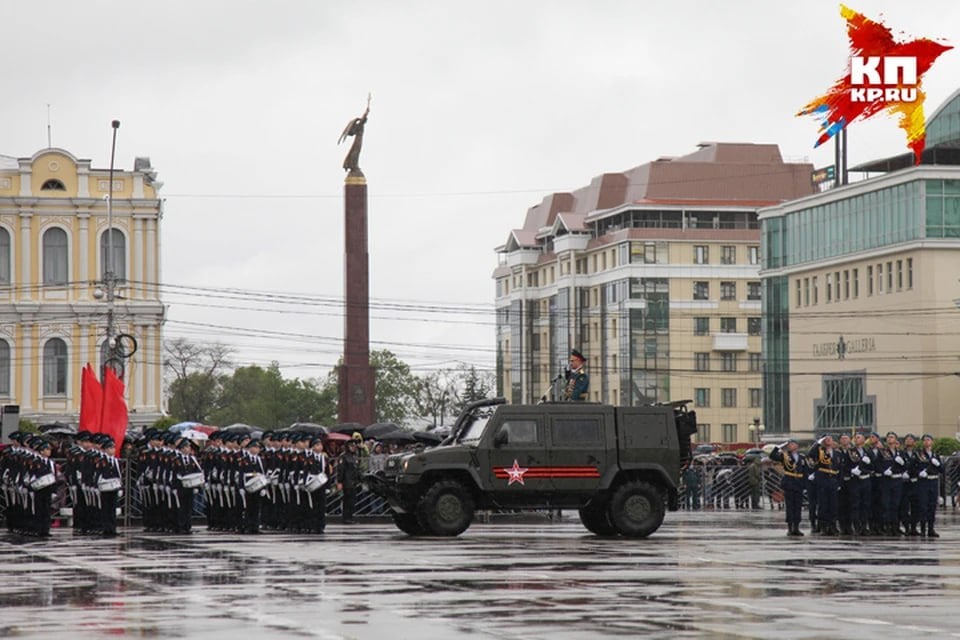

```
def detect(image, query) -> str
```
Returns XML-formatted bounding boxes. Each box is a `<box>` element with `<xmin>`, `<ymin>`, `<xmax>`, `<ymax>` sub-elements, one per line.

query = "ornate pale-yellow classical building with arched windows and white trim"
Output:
<box><xmin>0</xmin><ymin>148</ymin><xmax>164</xmax><ymax>424</ymax></box>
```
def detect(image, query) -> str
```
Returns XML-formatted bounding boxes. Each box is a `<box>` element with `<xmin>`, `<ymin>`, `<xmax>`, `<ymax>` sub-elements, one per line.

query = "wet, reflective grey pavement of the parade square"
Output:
<box><xmin>0</xmin><ymin>510</ymin><xmax>960</xmax><ymax>640</ymax></box>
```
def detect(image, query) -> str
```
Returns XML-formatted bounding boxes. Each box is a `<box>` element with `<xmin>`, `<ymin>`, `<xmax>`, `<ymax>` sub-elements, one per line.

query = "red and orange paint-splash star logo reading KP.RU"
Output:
<box><xmin>797</xmin><ymin>4</ymin><xmax>953</xmax><ymax>164</ymax></box>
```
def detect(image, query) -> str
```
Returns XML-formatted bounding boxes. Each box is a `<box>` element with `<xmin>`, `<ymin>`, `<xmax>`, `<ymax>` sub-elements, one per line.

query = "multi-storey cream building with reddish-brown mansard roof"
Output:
<box><xmin>494</xmin><ymin>143</ymin><xmax>814</xmax><ymax>443</ymax></box>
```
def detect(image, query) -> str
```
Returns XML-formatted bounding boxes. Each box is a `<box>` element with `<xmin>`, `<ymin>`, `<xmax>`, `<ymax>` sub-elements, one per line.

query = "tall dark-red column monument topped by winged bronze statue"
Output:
<box><xmin>337</xmin><ymin>99</ymin><xmax>375</xmax><ymax>426</ymax></box>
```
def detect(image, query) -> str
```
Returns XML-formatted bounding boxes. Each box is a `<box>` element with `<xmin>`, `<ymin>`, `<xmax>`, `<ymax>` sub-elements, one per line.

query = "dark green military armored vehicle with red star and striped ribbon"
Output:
<box><xmin>366</xmin><ymin>398</ymin><xmax>697</xmax><ymax>538</ymax></box>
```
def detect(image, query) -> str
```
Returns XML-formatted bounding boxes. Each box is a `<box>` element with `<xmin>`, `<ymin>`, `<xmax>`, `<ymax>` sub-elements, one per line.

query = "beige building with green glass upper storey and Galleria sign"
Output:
<box><xmin>760</xmin><ymin>87</ymin><xmax>960</xmax><ymax>436</ymax></box>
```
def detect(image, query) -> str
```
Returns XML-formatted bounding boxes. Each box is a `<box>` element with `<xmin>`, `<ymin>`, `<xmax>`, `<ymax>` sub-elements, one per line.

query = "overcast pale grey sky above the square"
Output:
<box><xmin>0</xmin><ymin>0</ymin><xmax>960</xmax><ymax>377</ymax></box>
